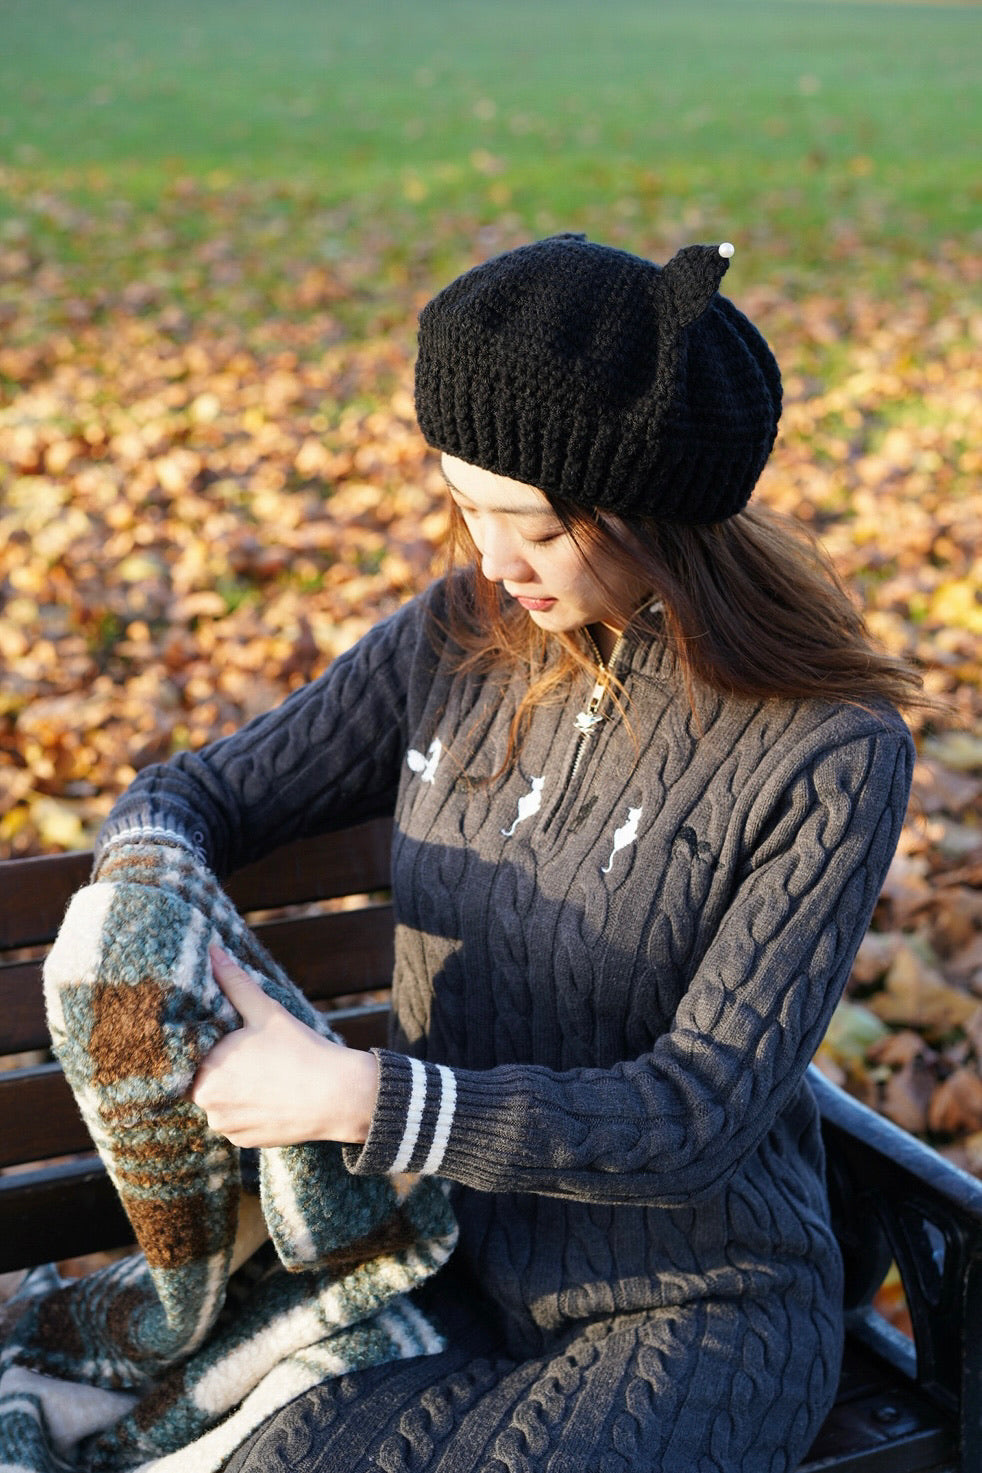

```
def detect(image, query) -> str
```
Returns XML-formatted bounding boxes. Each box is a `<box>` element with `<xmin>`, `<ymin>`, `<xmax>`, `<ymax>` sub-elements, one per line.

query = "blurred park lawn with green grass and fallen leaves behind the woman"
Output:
<box><xmin>0</xmin><ymin>0</ymin><xmax>982</xmax><ymax>1170</ymax></box>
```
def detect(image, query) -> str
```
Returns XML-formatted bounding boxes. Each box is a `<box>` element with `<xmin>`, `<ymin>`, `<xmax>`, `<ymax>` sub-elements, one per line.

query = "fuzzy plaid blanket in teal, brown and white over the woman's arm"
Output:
<box><xmin>0</xmin><ymin>835</ymin><xmax>455</xmax><ymax>1473</ymax></box>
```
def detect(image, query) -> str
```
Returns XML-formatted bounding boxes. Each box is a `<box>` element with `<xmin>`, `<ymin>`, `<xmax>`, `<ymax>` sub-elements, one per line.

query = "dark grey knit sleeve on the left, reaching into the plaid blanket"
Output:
<box><xmin>97</xmin><ymin>586</ymin><xmax>433</xmax><ymax>875</ymax></box>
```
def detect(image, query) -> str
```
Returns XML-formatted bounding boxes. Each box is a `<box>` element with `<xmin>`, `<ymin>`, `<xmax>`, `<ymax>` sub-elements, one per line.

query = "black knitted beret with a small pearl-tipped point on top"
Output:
<box><xmin>415</xmin><ymin>234</ymin><xmax>780</xmax><ymax>523</ymax></box>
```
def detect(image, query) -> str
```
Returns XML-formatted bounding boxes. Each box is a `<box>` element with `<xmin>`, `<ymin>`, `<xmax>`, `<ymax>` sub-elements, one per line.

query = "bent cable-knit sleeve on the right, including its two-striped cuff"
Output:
<box><xmin>347</xmin><ymin>728</ymin><xmax>913</xmax><ymax>1206</ymax></box>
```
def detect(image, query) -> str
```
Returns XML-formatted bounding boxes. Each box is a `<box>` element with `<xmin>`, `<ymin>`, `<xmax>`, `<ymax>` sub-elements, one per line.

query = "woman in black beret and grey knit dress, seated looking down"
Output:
<box><xmin>95</xmin><ymin>236</ymin><xmax>916</xmax><ymax>1473</ymax></box>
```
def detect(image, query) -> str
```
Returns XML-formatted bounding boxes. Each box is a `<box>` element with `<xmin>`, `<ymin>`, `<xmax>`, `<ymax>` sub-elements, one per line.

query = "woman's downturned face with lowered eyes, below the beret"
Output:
<box><xmin>442</xmin><ymin>454</ymin><xmax>646</xmax><ymax>654</ymax></box>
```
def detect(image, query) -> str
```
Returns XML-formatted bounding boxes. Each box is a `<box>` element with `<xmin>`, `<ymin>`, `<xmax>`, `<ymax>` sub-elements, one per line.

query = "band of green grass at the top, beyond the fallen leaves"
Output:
<box><xmin>0</xmin><ymin>0</ymin><xmax>982</xmax><ymax>276</ymax></box>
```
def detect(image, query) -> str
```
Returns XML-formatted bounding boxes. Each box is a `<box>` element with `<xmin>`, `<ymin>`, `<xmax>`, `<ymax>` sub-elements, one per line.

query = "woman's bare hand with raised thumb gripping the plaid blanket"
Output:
<box><xmin>190</xmin><ymin>947</ymin><xmax>378</xmax><ymax>1146</ymax></box>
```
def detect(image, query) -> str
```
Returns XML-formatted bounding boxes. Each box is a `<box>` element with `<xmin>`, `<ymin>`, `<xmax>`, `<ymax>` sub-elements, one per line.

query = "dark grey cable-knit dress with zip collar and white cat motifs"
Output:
<box><xmin>95</xmin><ymin>583</ymin><xmax>913</xmax><ymax>1473</ymax></box>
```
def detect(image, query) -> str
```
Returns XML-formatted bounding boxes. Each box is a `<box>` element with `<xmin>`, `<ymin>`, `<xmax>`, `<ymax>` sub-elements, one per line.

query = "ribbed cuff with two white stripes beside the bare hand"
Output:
<box><xmin>345</xmin><ymin>1049</ymin><xmax>456</xmax><ymax>1175</ymax></box>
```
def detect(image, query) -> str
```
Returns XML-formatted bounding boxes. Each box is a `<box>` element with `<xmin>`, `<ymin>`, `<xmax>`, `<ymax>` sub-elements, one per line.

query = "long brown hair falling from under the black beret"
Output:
<box><xmin>449</xmin><ymin>502</ymin><xmax>936</xmax><ymax>767</ymax></box>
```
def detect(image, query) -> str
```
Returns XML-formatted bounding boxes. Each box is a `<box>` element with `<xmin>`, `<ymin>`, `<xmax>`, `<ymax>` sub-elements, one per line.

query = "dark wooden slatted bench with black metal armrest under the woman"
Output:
<box><xmin>0</xmin><ymin>822</ymin><xmax>982</xmax><ymax>1473</ymax></box>
